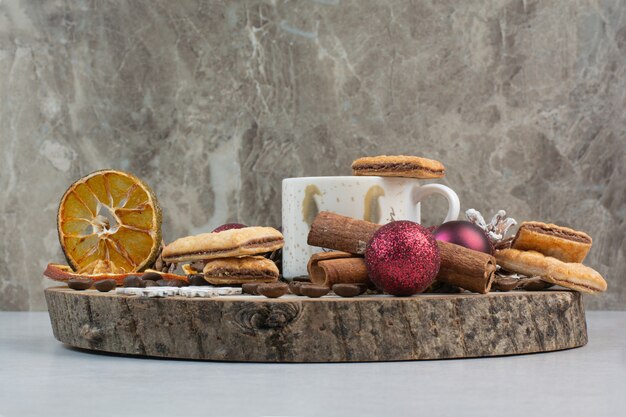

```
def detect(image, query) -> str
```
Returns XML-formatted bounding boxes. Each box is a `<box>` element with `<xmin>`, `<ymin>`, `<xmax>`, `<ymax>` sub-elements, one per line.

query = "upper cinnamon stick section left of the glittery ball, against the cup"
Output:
<box><xmin>307</xmin><ymin>211</ymin><xmax>380</xmax><ymax>255</ymax></box>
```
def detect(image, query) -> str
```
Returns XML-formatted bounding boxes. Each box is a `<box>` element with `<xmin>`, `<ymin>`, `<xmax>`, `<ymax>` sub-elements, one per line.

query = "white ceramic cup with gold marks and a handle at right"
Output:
<box><xmin>282</xmin><ymin>176</ymin><xmax>460</xmax><ymax>278</ymax></box>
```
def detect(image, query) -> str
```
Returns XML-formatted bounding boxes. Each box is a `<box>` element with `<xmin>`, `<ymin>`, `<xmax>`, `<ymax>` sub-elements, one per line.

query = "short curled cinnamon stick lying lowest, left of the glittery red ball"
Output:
<box><xmin>307</xmin><ymin>252</ymin><xmax>370</xmax><ymax>288</ymax></box>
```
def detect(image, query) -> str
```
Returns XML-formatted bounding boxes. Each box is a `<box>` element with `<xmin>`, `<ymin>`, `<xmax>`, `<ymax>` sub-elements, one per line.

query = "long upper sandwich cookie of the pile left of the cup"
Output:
<box><xmin>162</xmin><ymin>227</ymin><xmax>284</xmax><ymax>262</ymax></box>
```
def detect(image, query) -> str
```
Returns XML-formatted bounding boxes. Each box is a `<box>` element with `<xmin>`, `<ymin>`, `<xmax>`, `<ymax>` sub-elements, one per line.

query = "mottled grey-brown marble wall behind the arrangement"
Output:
<box><xmin>0</xmin><ymin>0</ymin><xmax>626</xmax><ymax>310</ymax></box>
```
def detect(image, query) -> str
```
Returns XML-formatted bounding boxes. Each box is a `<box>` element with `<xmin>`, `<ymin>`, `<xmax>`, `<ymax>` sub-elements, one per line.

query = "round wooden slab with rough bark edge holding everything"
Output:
<box><xmin>46</xmin><ymin>287</ymin><xmax>587</xmax><ymax>362</ymax></box>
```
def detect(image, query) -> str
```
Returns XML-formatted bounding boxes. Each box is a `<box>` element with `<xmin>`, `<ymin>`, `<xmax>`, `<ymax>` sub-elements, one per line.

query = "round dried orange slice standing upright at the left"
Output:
<box><xmin>57</xmin><ymin>170</ymin><xmax>161</xmax><ymax>274</ymax></box>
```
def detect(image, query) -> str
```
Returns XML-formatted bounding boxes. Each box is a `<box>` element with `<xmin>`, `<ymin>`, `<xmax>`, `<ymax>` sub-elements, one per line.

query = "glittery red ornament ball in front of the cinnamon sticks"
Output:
<box><xmin>365</xmin><ymin>220</ymin><xmax>440</xmax><ymax>295</ymax></box>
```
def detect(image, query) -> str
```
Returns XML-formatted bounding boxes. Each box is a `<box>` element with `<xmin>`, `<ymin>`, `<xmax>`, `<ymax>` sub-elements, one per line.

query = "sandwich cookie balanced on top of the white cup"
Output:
<box><xmin>352</xmin><ymin>155</ymin><xmax>446</xmax><ymax>179</ymax></box>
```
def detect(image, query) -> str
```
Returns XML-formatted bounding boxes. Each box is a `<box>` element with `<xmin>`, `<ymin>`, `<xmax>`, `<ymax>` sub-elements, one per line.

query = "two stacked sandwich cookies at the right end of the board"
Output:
<box><xmin>495</xmin><ymin>222</ymin><xmax>606</xmax><ymax>293</ymax></box>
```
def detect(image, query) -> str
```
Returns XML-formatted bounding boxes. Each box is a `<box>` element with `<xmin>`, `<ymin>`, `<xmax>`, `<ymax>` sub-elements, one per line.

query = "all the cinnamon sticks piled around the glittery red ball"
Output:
<box><xmin>307</xmin><ymin>211</ymin><xmax>496</xmax><ymax>294</ymax></box>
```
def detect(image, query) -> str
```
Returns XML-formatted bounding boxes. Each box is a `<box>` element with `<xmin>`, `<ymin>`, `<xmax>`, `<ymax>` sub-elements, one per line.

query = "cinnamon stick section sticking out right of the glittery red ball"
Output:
<box><xmin>436</xmin><ymin>240</ymin><xmax>496</xmax><ymax>294</ymax></box>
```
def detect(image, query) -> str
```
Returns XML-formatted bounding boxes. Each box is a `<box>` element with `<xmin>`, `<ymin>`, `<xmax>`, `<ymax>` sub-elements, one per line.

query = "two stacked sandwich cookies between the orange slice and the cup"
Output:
<box><xmin>162</xmin><ymin>227</ymin><xmax>284</xmax><ymax>285</ymax></box>
